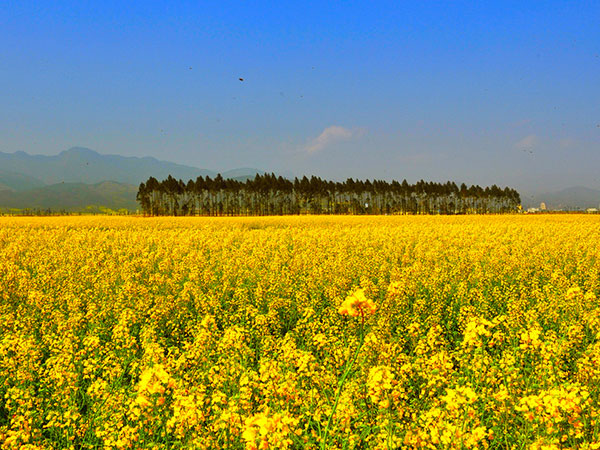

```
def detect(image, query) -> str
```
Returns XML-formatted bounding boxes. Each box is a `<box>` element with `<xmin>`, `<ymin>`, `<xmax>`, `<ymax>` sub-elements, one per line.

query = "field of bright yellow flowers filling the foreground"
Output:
<box><xmin>0</xmin><ymin>215</ymin><xmax>600</xmax><ymax>450</ymax></box>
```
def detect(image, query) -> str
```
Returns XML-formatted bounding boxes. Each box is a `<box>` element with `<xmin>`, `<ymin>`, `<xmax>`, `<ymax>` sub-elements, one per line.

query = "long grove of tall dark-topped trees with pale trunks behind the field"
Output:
<box><xmin>137</xmin><ymin>174</ymin><xmax>521</xmax><ymax>216</ymax></box>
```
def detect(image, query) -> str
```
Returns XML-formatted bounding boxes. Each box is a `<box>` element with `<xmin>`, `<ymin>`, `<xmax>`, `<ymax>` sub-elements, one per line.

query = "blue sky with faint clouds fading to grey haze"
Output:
<box><xmin>0</xmin><ymin>0</ymin><xmax>600</xmax><ymax>191</ymax></box>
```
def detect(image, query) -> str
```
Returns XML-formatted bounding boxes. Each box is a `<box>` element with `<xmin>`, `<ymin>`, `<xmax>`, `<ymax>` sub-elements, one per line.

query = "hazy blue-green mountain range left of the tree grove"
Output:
<box><xmin>0</xmin><ymin>147</ymin><xmax>264</xmax><ymax>212</ymax></box>
